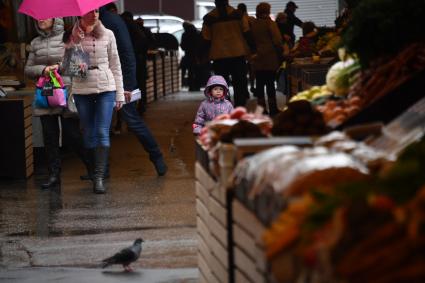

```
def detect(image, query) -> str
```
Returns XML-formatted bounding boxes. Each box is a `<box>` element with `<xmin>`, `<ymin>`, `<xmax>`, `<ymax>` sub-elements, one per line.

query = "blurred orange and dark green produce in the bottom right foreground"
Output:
<box><xmin>264</xmin><ymin>141</ymin><xmax>425</xmax><ymax>283</ymax></box>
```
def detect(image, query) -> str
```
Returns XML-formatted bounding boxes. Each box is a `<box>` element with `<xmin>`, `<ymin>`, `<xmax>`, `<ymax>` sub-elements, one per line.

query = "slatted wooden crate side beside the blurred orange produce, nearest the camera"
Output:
<box><xmin>232</xmin><ymin>199</ymin><xmax>269</xmax><ymax>283</ymax></box>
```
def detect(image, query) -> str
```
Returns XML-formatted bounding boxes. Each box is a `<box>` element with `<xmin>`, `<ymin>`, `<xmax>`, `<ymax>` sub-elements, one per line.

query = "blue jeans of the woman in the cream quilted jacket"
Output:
<box><xmin>74</xmin><ymin>91</ymin><xmax>115</xmax><ymax>148</ymax></box>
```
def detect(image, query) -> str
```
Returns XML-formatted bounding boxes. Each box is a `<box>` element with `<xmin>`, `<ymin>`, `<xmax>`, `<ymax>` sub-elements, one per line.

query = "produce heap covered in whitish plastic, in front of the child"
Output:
<box><xmin>234</xmin><ymin>132</ymin><xmax>391</xmax><ymax>224</ymax></box>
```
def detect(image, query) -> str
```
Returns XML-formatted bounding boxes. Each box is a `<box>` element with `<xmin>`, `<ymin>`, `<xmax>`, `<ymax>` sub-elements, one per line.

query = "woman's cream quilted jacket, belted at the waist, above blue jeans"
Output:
<box><xmin>71</xmin><ymin>21</ymin><xmax>124</xmax><ymax>101</ymax></box>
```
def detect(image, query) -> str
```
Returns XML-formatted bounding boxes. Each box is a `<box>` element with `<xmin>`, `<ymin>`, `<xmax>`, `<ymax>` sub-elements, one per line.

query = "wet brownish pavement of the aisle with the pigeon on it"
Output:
<box><xmin>0</xmin><ymin>92</ymin><xmax>203</xmax><ymax>282</ymax></box>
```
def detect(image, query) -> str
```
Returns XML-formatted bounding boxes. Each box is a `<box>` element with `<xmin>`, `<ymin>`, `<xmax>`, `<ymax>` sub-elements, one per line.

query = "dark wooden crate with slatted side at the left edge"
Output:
<box><xmin>0</xmin><ymin>96</ymin><xmax>34</xmax><ymax>178</ymax></box>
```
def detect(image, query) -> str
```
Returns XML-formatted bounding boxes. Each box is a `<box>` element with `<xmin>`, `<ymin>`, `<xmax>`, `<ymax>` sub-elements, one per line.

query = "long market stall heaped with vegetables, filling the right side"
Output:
<box><xmin>197</xmin><ymin>0</ymin><xmax>425</xmax><ymax>283</ymax></box>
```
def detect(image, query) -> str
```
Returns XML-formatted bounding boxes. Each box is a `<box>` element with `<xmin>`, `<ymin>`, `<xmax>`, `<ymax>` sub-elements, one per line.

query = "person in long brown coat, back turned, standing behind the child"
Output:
<box><xmin>252</xmin><ymin>2</ymin><xmax>283</xmax><ymax>116</ymax></box>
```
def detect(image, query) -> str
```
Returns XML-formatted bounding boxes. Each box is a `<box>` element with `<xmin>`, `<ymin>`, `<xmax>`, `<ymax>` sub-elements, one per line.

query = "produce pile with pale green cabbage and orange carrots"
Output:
<box><xmin>290</xmin><ymin>43</ymin><xmax>425</xmax><ymax>128</ymax></box>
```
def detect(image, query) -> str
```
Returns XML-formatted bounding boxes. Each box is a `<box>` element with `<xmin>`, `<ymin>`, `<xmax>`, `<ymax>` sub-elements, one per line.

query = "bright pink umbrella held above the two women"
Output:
<box><xmin>18</xmin><ymin>0</ymin><xmax>115</xmax><ymax>20</ymax></box>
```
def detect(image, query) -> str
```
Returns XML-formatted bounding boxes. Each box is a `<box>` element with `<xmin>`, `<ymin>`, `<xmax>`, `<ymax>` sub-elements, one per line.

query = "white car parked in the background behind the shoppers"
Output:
<box><xmin>133</xmin><ymin>14</ymin><xmax>184</xmax><ymax>33</ymax></box>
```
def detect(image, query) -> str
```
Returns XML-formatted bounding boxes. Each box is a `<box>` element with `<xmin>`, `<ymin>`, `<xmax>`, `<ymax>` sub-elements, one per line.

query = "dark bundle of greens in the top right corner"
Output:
<box><xmin>343</xmin><ymin>0</ymin><xmax>425</xmax><ymax>68</ymax></box>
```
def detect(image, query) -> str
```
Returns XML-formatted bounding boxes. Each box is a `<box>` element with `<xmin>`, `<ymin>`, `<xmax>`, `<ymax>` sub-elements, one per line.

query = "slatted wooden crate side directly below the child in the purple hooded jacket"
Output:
<box><xmin>195</xmin><ymin>162</ymin><xmax>233</xmax><ymax>283</ymax></box>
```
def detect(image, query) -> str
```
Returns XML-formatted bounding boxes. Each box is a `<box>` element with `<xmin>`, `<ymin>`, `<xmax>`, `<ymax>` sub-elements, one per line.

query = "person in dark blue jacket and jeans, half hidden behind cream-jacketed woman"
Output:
<box><xmin>100</xmin><ymin>7</ymin><xmax>168</xmax><ymax>176</ymax></box>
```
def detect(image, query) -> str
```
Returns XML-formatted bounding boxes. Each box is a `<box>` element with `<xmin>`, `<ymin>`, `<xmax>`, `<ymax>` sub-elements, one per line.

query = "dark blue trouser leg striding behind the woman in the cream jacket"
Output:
<box><xmin>120</xmin><ymin>102</ymin><xmax>162</xmax><ymax>161</ymax></box>
